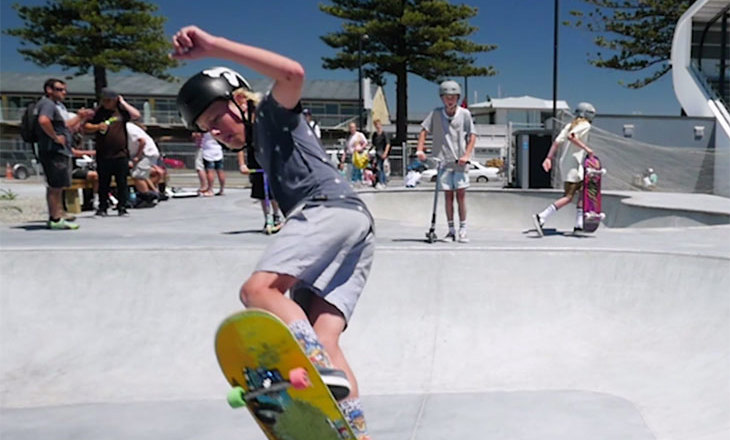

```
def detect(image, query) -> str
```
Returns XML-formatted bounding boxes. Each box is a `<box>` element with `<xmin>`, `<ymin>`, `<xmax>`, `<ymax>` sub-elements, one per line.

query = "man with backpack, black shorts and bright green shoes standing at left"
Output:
<box><xmin>30</xmin><ymin>78</ymin><xmax>94</xmax><ymax>230</ymax></box>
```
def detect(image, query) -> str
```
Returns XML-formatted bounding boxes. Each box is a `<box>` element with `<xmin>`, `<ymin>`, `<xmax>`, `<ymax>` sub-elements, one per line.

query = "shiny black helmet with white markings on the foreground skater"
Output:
<box><xmin>177</xmin><ymin>67</ymin><xmax>251</xmax><ymax>131</ymax></box>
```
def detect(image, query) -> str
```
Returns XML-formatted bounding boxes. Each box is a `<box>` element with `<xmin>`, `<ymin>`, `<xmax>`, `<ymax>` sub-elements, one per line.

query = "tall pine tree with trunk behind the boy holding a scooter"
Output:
<box><xmin>319</xmin><ymin>0</ymin><xmax>496</xmax><ymax>143</ymax></box>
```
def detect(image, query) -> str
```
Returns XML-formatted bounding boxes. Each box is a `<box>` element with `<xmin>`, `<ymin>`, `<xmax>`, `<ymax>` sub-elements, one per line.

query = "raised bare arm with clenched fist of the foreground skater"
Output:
<box><xmin>171</xmin><ymin>26</ymin><xmax>304</xmax><ymax>109</ymax></box>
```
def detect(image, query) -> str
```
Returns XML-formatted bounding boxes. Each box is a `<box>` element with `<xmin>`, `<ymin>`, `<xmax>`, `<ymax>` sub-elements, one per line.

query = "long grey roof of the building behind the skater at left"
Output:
<box><xmin>0</xmin><ymin>72</ymin><xmax>370</xmax><ymax>101</ymax></box>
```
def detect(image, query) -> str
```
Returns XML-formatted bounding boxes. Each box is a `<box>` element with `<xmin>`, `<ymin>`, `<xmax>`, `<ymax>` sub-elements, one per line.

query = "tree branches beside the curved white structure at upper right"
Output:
<box><xmin>564</xmin><ymin>0</ymin><xmax>691</xmax><ymax>89</ymax></box>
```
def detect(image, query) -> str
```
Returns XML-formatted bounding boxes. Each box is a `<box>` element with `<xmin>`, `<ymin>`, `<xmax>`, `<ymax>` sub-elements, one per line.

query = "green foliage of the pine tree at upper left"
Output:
<box><xmin>3</xmin><ymin>0</ymin><xmax>177</xmax><ymax>92</ymax></box>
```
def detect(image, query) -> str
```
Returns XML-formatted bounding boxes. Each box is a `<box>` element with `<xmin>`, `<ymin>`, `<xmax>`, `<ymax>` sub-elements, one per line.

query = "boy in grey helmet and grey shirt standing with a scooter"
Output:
<box><xmin>417</xmin><ymin>81</ymin><xmax>477</xmax><ymax>243</ymax></box>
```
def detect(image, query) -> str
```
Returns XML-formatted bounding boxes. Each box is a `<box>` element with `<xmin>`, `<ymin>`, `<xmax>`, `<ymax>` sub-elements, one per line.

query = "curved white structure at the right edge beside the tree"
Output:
<box><xmin>671</xmin><ymin>0</ymin><xmax>730</xmax><ymax>197</ymax></box>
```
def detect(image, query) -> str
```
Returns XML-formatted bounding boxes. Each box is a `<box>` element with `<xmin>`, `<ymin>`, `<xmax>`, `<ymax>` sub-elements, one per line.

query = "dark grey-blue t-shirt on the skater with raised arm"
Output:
<box><xmin>254</xmin><ymin>93</ymin><xmax>373</xmax><ymax>223</ymax></box>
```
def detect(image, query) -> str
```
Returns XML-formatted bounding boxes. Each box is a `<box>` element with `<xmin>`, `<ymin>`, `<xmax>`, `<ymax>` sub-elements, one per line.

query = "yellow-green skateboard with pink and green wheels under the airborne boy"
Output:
<box><xmin>215</xmin><ymin>309</ymin><xmax>356</xmax><ymax>440</ymax></box>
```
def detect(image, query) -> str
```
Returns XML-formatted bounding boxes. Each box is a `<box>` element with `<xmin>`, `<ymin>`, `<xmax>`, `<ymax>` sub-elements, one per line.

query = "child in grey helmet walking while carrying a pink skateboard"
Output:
<box><xmin>532</xmin><ymin>102</ymin><xmax>596</xmax><ymax>237</ymax></box>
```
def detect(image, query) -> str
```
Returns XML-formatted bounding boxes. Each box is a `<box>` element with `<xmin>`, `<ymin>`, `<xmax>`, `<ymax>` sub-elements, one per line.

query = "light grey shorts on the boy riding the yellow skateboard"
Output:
<box><xmin>255</xmin><ymin>206</ymin><xmax>375</xmax><ymax>321</ymax></box>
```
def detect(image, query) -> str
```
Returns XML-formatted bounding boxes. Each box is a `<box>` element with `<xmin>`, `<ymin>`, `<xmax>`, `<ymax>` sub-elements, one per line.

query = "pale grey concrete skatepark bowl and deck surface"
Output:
<box><xmin>0</xmin><ymin>186</ymin><xmax>730</xmax><ymax>440</ymax></box>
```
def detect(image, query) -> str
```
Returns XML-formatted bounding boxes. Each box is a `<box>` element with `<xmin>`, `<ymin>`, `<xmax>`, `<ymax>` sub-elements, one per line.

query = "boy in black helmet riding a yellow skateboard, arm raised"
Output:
<box><xmin>172</xmin><ymin>26</ymin><xmax>374</xmax><ymax>439</ymax></box>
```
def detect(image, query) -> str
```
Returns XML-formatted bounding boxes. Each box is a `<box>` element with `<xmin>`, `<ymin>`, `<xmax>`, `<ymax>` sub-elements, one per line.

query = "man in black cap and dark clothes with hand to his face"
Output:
<box><xmin>84</xmin><ymin>87</ymin><xmax>140</xmax><ymax>217</ymax></box>
